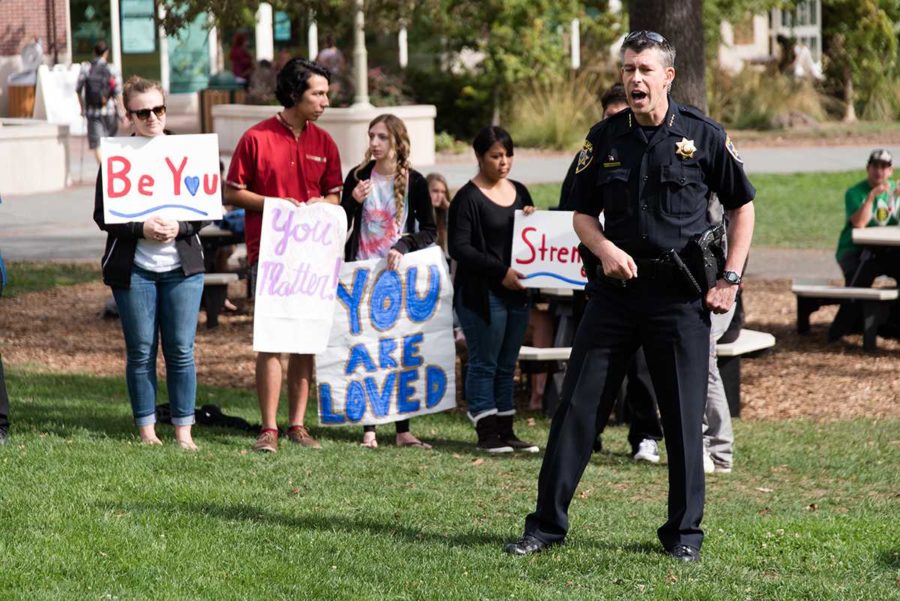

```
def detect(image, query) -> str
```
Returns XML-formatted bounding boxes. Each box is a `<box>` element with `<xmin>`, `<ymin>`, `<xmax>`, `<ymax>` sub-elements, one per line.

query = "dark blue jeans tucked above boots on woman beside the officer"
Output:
<box><xmin>456</xmin><ymin>292</ymin><xmax>528</xmax><ymax>421</ymax></box>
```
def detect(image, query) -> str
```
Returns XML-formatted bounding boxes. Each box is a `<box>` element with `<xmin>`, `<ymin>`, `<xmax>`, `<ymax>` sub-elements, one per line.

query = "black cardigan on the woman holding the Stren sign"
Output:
<box><xmin>447</xmin><ymin>180</ymin><xmax>534</xmax><ymax>323</ymax></box>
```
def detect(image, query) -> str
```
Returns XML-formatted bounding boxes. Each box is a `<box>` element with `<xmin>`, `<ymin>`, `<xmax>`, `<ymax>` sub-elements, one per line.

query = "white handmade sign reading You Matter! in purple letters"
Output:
<box><xmin>253</xmin><ymin>198</ymin><xmax>347</xmax><ymax>355</ymax></box>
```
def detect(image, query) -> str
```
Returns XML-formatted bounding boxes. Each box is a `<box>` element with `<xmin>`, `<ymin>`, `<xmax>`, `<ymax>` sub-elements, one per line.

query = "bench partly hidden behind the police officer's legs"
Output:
<box><xmin>519</xmin><ymin>329</ymin><xmax>775</xmax><ymax>417</ymax></box>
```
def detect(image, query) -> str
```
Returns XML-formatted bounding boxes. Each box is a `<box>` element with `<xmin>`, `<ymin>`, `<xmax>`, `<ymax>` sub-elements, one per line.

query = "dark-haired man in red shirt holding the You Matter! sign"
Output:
<box><xmin>225</xmin><ymin>58</ymin><xmax>343</xmax><ymax>453</ymax></box>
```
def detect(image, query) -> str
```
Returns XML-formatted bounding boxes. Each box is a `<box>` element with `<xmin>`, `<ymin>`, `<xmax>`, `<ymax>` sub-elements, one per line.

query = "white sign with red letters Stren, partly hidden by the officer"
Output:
<box><xmin>512</xmin><ymin>211</ymin><xmax>587</xmax><ymax>289</ymax></box>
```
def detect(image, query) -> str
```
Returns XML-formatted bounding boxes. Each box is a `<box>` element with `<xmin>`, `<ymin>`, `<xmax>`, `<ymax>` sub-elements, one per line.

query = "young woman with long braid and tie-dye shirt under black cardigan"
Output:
<box><xmin>341</xmin><ymin>115</ymin><xmax>437</xmax><ymax>449</ymax></box>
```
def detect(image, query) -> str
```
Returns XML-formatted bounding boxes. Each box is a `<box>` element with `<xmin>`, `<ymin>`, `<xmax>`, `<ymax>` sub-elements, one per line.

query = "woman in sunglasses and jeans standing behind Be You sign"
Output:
<box><xmin>94</xmin><ymin>77</ymin><xmax>203</xmax><ymax>450</ymax></box>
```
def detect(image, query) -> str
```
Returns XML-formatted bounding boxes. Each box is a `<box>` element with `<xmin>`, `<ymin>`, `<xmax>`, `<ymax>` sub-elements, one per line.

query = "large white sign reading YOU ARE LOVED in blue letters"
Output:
<box><xmin>316</xmin><ymin>247</ymin><xmax>456</xmax><ymax>426</ymax></box>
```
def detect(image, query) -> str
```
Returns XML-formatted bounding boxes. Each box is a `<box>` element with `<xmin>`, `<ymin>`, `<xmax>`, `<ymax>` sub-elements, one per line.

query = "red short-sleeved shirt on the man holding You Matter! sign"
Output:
<box><xmin>226</xmin><ymin>115</ymin><xmax>343</xmax><ymax>264</ymax></box>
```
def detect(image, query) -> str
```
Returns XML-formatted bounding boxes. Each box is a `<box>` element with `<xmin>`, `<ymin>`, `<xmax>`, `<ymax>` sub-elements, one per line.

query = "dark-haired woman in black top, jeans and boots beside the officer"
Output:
<box><xmin>448</xmin><ymin>127</ymin><xmax>538</xmax><ymax>453</ymax></box>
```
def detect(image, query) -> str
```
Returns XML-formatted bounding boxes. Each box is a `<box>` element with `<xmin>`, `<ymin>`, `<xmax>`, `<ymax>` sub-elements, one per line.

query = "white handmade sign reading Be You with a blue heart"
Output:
<box><xmin>100</xmin><ymin>134</ymin><xmax>222</xmax><ymax>223</ymax></box>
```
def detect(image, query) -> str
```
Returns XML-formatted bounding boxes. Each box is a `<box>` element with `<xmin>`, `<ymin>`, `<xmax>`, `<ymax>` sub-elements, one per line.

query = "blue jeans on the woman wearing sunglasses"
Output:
<box><xmin>113</xmin><ymin>265</ymin><xmax>203</xmax><ymax>427</ymax></box>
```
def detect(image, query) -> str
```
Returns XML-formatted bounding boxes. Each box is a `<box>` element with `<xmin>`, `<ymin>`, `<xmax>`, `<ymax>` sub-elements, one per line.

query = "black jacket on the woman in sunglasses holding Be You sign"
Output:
<box><xmin>94</xmin><ymin>171</ymin><xmax>206</xmax><ymax>288</ymax></box>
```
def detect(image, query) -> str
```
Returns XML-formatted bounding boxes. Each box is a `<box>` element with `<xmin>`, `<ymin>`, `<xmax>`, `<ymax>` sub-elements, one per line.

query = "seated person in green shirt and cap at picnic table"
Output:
<box><xmin>836</xmin><ymin>149</ymin><xmax>900</xmax><ymax>287</ymax></box>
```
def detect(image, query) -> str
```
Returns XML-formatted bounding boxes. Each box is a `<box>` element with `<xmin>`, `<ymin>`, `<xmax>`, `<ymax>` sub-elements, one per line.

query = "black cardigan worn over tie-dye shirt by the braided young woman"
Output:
<box><xmin>341</xmin><ymin>161</ymin><xmax>437</xmax><ymax>261</ymax></box>
